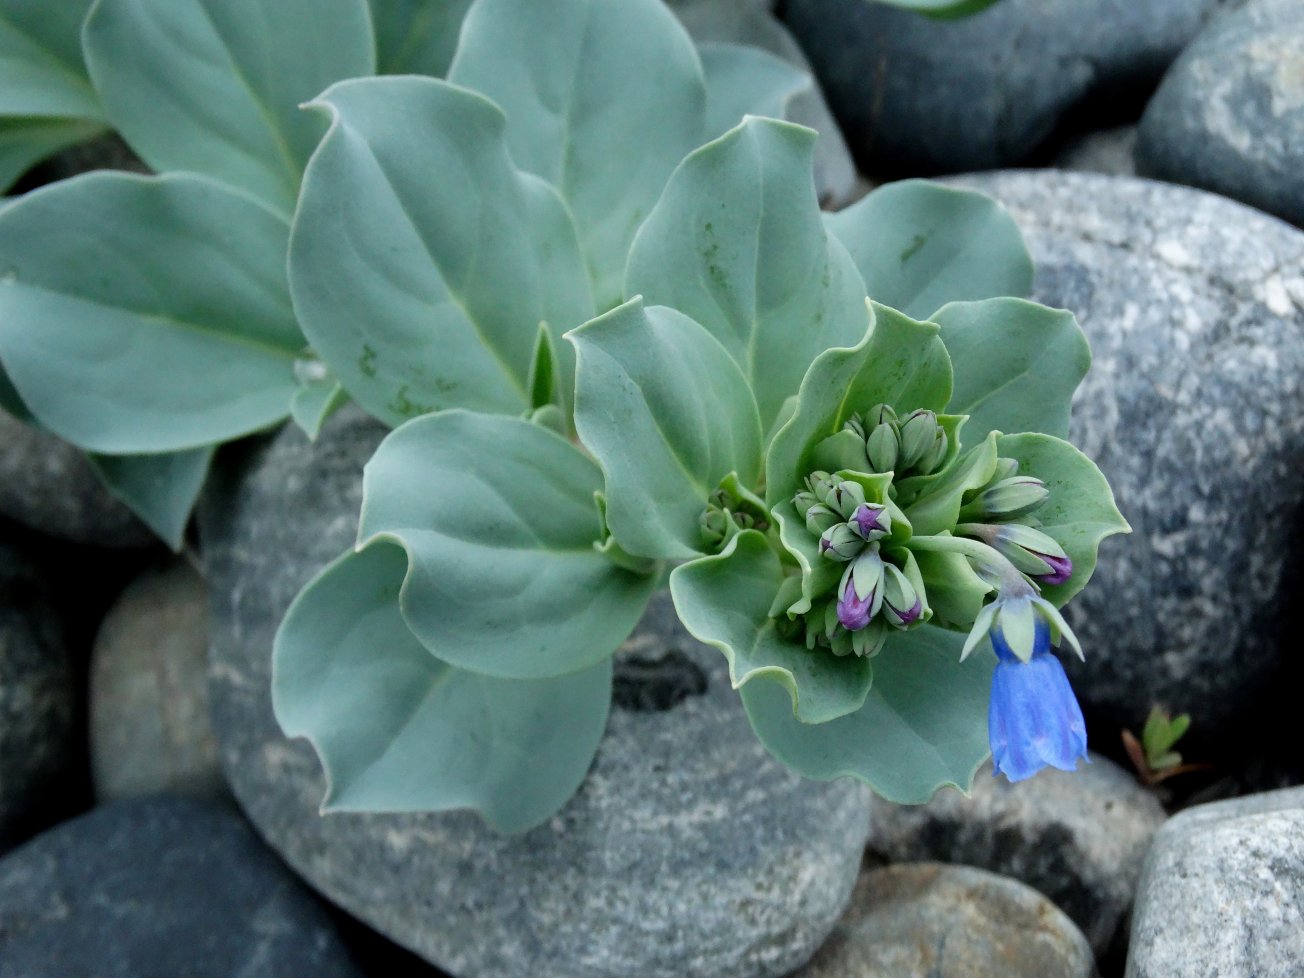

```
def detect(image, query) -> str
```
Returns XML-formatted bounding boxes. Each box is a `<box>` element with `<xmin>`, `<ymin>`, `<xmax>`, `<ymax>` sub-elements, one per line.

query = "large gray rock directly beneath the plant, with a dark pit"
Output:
<box><xmin>201</xmin><ymin>413</ymin><xmax>868</xmax><ymax>978</ymax></box>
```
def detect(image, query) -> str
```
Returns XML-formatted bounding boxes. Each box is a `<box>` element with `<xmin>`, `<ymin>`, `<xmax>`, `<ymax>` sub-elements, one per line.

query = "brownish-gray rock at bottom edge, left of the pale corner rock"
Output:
<box><xmin>793</xmin><ymin>862</ymin><xmax>1094</xmax><ymax>978</ymax></box>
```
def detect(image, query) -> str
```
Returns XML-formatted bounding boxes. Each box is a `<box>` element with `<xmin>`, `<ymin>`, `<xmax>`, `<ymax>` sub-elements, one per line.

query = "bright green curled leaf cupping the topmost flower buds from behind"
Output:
<box><xmin>765</xmin><ymin>303</ymin><xmax>951</xmax><ymax>506</ymax></box>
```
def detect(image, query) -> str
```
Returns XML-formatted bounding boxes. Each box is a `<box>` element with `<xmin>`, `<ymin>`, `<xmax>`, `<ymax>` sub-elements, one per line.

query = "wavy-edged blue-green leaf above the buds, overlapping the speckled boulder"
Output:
<box><xmin>932</xmin><ymin>299</ymin><xmax>1091</xmax><ymax>442</ymax></box>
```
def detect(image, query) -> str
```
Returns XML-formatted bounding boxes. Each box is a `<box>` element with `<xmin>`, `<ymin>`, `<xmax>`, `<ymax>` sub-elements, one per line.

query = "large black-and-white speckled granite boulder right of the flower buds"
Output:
<box><xmin>958</xmin><ymin>171</ymin><xmax>1304</xmax><ymax>750</ymax></box>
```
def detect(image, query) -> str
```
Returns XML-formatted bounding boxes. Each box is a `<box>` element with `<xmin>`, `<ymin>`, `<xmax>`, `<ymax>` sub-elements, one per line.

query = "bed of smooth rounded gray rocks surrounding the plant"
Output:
<box><xmin>0</xmin><ymin>0</ymin><xmax>1304</xmax><ymax>978</ymax></box>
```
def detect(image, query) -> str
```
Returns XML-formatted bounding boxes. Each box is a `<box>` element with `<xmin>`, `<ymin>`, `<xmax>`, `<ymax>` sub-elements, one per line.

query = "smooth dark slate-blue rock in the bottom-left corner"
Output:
<box><xmin>0</xmin><ymin>799</ymin><xmax>359</xmax><ymax>978</ymax></box>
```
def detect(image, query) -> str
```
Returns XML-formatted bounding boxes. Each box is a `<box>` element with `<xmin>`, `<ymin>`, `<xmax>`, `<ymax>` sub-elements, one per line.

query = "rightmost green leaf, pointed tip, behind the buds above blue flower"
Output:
<box><xmin>996</xmin><ymin>433</ymin><xmax>1132</xmax><ymax>608</ymax></box>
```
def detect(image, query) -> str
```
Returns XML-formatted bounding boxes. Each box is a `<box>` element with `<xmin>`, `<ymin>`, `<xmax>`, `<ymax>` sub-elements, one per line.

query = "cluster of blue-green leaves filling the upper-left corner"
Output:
<box><xmin>0</xmin><ymin>0</ymin><xmax>469</xmax><ymax>546</ymax></box>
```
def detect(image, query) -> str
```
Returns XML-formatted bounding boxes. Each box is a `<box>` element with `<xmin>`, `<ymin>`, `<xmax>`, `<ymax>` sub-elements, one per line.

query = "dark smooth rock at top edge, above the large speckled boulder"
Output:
<box><xmin>785</xmin><ymin>0</ymin><xmax>1218</xmax><ymax>176</ymax></box>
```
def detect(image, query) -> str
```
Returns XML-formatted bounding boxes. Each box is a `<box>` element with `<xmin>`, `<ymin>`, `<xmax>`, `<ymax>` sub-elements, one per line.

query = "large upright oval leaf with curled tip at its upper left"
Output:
<box><xmin>289</xmin><ymin>77</ymin><xmax>593</xmax><ymax>425</ymax></box>
